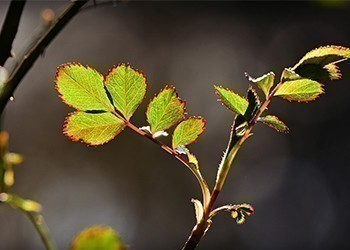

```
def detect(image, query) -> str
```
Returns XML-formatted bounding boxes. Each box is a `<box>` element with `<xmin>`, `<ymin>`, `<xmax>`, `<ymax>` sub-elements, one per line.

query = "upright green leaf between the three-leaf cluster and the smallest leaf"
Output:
<box><xmin>146</xmin><ymin>86</ymin><xmax>185</xmax><ymax>134</ymax></box>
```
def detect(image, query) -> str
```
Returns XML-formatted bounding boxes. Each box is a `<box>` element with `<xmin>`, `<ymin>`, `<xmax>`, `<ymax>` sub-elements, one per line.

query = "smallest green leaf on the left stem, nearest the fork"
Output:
<box><xmin>173</xmin><ymin>117</ymin><xmax>205</xmax><ymax>148</ymax></box>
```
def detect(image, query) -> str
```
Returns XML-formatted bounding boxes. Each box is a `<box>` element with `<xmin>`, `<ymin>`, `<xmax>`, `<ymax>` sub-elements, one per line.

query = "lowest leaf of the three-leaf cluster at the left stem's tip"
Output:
<box><xmin>64</xmin><ymin>111</ymin><xmax>125</xmax><ymax>145</ymax></box>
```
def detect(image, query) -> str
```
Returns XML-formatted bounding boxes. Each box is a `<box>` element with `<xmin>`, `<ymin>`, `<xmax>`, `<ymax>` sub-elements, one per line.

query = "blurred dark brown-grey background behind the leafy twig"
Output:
<box><xmin>0</xmin><ymin>1</ymin><xmax>350</xmax><ymax>250</ymax></box>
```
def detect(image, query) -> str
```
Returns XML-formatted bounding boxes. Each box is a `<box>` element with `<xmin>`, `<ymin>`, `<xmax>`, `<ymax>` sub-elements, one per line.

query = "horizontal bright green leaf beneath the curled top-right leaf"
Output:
<box><xmin>274</xmin><ymin>79</ymin><xmax>324</xmax><ymax>102</ymax></box>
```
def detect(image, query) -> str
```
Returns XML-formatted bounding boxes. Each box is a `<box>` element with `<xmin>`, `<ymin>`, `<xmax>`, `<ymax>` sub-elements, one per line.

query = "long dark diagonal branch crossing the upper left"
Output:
<box><xmin>0</xmin><ymin>0</ymin><xmax>88</xmax><ymax>114</ymax></box>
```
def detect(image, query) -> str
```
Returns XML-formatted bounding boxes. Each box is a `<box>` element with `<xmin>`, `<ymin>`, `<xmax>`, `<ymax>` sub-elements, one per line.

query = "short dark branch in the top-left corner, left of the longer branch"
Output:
<box><xmin>0</xmin><ymin>0</ymin><xmax>26</xmax><ymax>66</ymax></box>
